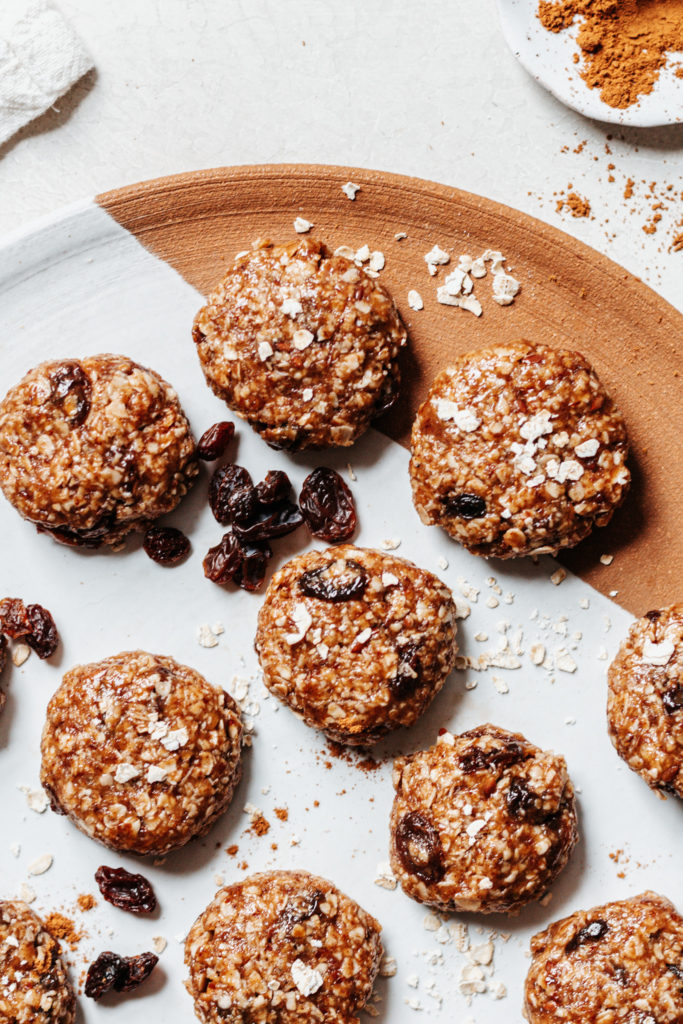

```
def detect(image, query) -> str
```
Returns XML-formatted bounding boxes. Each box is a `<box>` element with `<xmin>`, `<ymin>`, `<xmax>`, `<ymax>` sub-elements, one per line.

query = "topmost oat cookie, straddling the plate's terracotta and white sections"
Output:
<box><xmin>194</xmin><ymin>239</ymin><xmax>408</xmax><ymax>450</ymax></box>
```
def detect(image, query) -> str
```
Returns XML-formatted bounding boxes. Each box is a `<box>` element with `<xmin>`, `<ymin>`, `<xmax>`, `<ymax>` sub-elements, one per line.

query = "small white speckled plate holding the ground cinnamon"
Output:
<box><xmin>497</xmin><ymin>0</ymin><xmax>683</xmax><ymax>128</ymax></box>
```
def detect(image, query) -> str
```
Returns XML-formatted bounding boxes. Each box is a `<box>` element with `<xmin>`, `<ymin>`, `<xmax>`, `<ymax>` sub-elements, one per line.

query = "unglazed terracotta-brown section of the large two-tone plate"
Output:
<box><xmin>98</xmin><ymin>165</ymin><xmax>683</xmax><ymax>613</ymax></box>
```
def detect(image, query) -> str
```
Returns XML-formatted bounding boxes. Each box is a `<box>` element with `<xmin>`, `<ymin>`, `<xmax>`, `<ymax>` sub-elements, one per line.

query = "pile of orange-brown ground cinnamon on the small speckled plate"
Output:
<box><xmin>539</xmin><ymin>0</ymin><xmax>683</xmax><ymax>109</ymax></box>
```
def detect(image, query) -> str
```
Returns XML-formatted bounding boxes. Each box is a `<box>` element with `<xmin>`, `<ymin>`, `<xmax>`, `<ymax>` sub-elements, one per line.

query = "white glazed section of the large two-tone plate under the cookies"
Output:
<box><xmin>0</xmin><ymin>184</ymin><xmax>683</xmax><ymax>1024</ymax></box>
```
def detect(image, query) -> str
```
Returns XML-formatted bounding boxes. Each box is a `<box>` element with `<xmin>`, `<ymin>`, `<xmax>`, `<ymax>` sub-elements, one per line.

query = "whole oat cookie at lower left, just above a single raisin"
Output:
<box><xmin>40</xmin><ymin>650</ymin><xmax>242</xmax><ymax>857</ymax></box>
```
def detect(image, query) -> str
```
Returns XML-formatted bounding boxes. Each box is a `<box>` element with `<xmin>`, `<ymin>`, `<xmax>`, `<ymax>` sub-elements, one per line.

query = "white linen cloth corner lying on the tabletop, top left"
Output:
<box><xmin>0</xmin><ymin>0</ymin><xmax>93</xmax><ymax>144</ymax></box>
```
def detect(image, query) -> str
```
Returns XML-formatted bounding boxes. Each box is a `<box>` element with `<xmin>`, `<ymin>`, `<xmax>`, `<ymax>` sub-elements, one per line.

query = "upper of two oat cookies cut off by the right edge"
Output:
<box><xmin>607</xmin><ymin>604</ymin><xmax>683</xmax><ymax>798</ymax></box>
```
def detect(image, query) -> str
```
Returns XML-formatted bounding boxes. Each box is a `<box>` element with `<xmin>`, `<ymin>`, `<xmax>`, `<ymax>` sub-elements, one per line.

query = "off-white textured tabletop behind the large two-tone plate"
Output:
<box><xmin>0</xmin><ymin>0</ymin><xmax>683</xmax><ymax>308</ymax></box>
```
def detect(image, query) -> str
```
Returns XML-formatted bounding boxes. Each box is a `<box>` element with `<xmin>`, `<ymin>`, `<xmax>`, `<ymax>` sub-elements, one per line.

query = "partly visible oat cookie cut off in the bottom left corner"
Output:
<box><xmin>0</xmin><ymin>900</ymin><xmax>76</xmax><ymax>1024</ymax></box>
